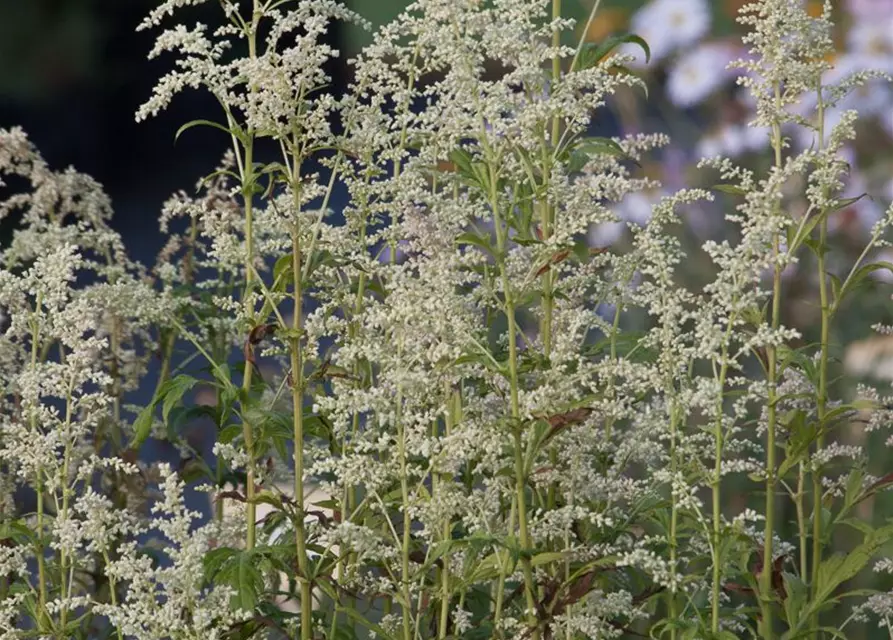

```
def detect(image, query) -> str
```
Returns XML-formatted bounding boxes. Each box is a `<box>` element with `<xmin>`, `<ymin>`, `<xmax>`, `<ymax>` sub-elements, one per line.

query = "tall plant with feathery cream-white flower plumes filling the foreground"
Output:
<box><xmin>0</xmin><ymin>0</ymin><xmax>893</xmax><ymax>640</ymax></box>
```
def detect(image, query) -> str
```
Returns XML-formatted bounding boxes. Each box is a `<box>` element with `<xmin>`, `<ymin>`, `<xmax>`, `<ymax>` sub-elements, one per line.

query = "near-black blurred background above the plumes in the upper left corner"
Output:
<box><xmin>0</xmin><ymin>0</ymin><xmax>376</xmax><ymax>266</ymax></box>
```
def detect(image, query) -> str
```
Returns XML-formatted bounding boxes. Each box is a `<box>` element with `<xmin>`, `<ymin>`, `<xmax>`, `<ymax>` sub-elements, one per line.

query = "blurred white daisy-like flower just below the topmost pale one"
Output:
<box><xmin>667</xmin><ymin>42</ymin><xmax>735</xmax><ymax>107</ymax></box>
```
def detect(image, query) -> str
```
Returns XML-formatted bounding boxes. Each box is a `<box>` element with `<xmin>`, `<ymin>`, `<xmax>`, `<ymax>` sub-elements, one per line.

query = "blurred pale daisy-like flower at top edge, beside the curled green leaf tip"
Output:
<box><xmin>622</xmin><ymin>0</ymin><xmax>710</xmax><ymax>66</ymax></box>
